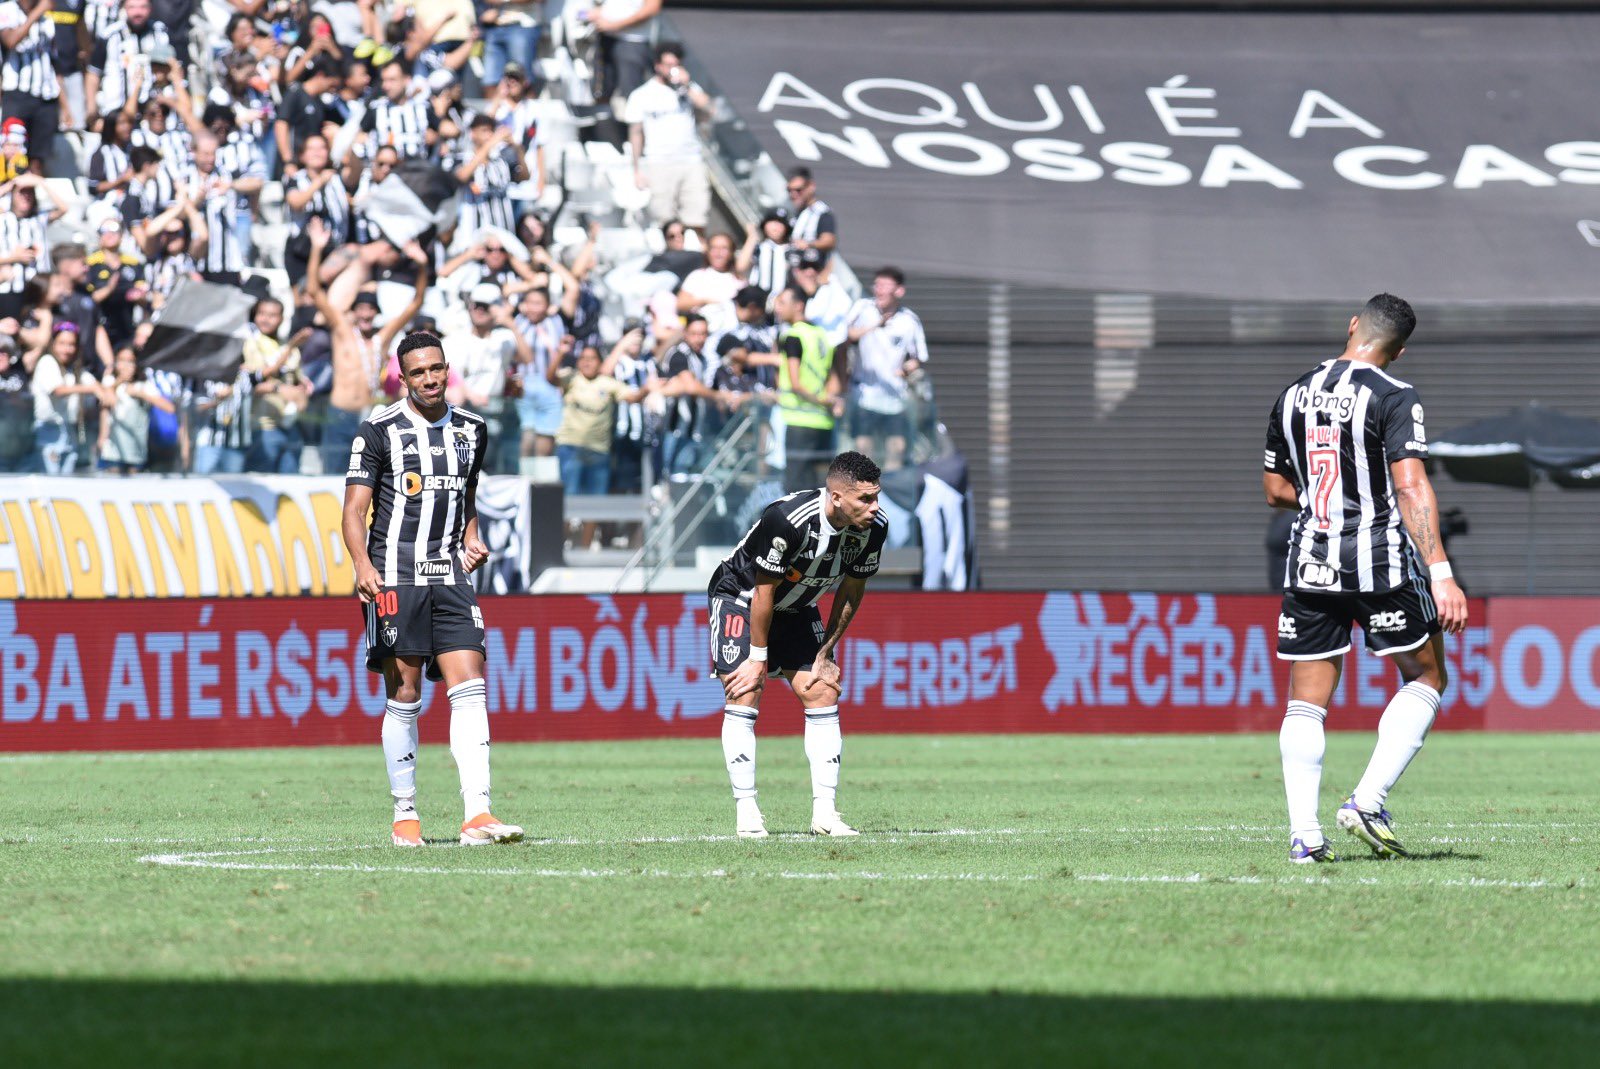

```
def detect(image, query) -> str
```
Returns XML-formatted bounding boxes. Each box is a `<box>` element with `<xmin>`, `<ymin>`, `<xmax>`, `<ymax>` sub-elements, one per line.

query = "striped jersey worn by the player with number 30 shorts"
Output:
<box><xmin>344</xmin><ymin>400</ymin><xmax>490</xmax><ymax>586</ymax></box>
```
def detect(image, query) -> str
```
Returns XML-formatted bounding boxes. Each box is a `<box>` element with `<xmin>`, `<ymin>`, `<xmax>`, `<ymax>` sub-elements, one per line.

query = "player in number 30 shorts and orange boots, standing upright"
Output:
<box><xmin>344</xmin><ymin>331</ymin><xmax>522</xmax><ymax>847</ymax></box>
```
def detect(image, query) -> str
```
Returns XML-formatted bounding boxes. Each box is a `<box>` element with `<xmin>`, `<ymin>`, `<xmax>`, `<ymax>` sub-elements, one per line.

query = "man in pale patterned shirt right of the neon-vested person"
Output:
<box><xmin>848</xmin><ymin>267</ymin><xmax>928</xmax><ymax>470</ymax></box>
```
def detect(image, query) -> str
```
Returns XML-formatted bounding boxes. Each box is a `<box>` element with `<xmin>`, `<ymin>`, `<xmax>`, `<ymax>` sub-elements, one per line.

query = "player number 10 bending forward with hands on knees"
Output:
<box><xmin>707</xmin><ymin>453</ymin><xmax>890</xmax><ymax>839</ymax></box>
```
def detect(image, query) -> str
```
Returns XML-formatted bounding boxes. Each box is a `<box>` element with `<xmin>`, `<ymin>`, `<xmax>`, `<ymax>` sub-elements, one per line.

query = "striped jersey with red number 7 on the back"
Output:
<box><xmin>1266</xmin><ymin>360</ymin><xmax>1427</xmax><ymax>594</ymax></box>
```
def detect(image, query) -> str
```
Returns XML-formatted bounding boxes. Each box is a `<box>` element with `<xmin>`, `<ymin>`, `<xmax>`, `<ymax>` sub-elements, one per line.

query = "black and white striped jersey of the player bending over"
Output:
<box><xmin>707</xmin><ymin>486</ymin><xmax>890</xmax><ymax>613</ymax></box>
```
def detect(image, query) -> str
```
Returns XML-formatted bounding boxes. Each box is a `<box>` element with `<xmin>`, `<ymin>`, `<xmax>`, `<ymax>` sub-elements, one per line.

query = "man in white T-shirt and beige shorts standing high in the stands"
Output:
<box><xmin>624</xmin><ymin>43</ymin><xmax>710</xmax><ymax>234</ymax></box>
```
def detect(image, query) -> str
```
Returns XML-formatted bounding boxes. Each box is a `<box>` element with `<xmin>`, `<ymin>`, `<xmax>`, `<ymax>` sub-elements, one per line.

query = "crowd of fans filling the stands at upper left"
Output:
<box><xmin>0</xmin><ymin>0</ymin><xmax>926</xmax><ymax>493</ymax></box>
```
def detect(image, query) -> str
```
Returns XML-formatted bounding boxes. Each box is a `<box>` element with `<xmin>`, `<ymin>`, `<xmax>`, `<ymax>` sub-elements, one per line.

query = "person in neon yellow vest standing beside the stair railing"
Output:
<box><xmin>773</xmin><ymin>286</ymin><xmax>845</xmax><ymax>493</ymax></box>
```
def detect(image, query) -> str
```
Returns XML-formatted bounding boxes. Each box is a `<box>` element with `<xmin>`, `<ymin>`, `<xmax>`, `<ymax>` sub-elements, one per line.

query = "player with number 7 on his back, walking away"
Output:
<box><xmin>1262</xmin><ymin>293</ymin><xmax>1467</xmax><ymax>864</ymax></box>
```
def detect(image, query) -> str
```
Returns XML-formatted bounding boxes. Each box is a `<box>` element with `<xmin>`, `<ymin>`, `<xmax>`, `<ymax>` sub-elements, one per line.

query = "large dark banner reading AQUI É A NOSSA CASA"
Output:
<box><xmin>674</xmin><ymin>5</ymin><xmax>1600</xmax><ymax>304</ymax></box>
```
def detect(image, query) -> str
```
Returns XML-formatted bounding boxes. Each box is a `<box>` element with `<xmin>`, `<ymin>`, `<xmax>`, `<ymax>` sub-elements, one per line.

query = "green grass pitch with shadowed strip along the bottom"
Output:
<box><xmin>0</xmin><ymin>735</ymin><xmax>1600</xmax><ymax>1069</ymax></box>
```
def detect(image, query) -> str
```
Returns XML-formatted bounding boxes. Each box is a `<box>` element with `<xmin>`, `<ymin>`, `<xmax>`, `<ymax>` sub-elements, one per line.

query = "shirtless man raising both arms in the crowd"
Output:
<box><xmin>306</xmin><ymin>219</ymin><xmax>427</xmax><ymax>474</ymax></box>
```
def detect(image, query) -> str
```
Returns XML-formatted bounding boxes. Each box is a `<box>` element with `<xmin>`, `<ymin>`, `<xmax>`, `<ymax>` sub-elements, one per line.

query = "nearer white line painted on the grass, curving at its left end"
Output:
<box><xmin>139</xmin><ymin>847</ymin><xmax>1589</xmax><ymax>890</ymax></box>
